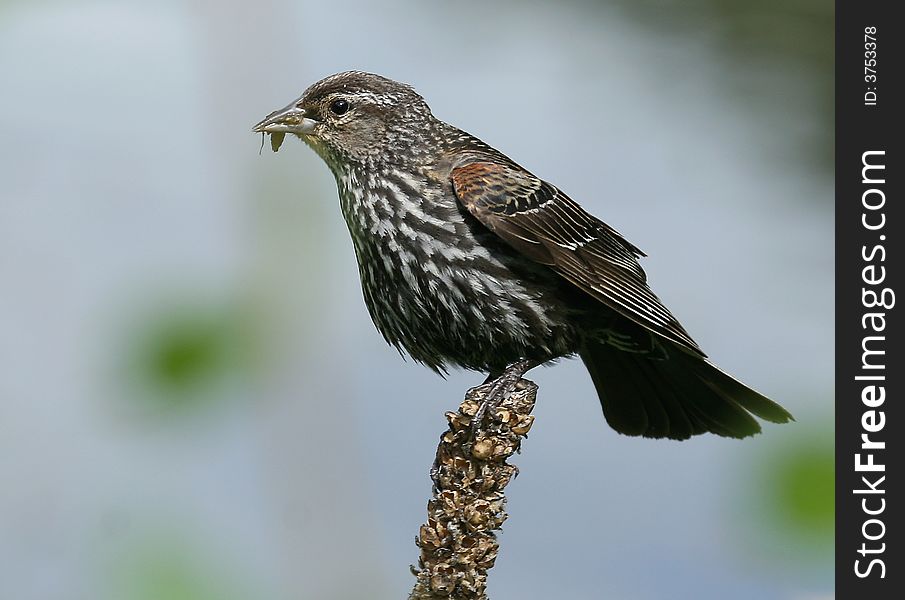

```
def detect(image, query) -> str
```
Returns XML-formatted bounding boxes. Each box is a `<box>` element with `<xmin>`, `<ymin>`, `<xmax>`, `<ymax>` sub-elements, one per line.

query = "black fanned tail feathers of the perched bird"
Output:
<box><xmin>581</xmin><ymin>342</ymin><xmax>792</xmax><ymax>440</ymax></box>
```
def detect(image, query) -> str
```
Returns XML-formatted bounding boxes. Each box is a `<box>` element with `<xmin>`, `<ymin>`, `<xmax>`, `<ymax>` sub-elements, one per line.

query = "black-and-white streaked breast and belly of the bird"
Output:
<box><xmin>337</xmin><ymin>165</ymin><xmax>578</xmax><ymax>371</ymax></box>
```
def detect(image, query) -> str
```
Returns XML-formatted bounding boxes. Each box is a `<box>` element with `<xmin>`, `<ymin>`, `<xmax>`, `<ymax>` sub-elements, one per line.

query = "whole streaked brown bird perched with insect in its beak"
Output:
<box><xmin>252</xmin><ymin>71</ymin><xmax>793</xmax><ymax>440</ymax></box>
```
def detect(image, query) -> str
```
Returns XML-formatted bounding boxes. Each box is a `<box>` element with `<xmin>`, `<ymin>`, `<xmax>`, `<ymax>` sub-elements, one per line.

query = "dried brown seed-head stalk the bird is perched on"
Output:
<box><xmin>409</xmin><ymin>379</ymin><xmax>537</xmax><ymax>600</ymax></box>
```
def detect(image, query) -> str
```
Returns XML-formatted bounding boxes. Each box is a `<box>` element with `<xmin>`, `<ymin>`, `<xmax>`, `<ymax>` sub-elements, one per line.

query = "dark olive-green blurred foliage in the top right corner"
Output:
<box><xmin>600</xmin><ymin>0</ymin><xmax>835</xmax><ymax>172</ymax></box>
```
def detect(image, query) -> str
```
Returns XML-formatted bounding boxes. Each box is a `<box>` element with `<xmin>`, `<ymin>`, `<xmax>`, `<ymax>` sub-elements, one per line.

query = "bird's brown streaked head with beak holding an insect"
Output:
<box><xmin>253</xmin><ymin>71</ymin><xmax>433</xmax><ymax>167</ymax></box>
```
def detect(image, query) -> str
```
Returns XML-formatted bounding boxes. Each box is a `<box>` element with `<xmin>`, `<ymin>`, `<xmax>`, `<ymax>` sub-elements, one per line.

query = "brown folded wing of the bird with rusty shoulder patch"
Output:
<box><xmin>451</xmin><ymin>162</ymin><xmax>704</xmax><ymax>356</ymax></box>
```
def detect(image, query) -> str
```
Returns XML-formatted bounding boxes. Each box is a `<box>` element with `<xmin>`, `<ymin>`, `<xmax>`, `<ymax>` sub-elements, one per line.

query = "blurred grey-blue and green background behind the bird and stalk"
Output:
<box><xmin>0</xmin><ymin>0</ymin><xmax>834</xmax><ymax>600</ymax></box>
